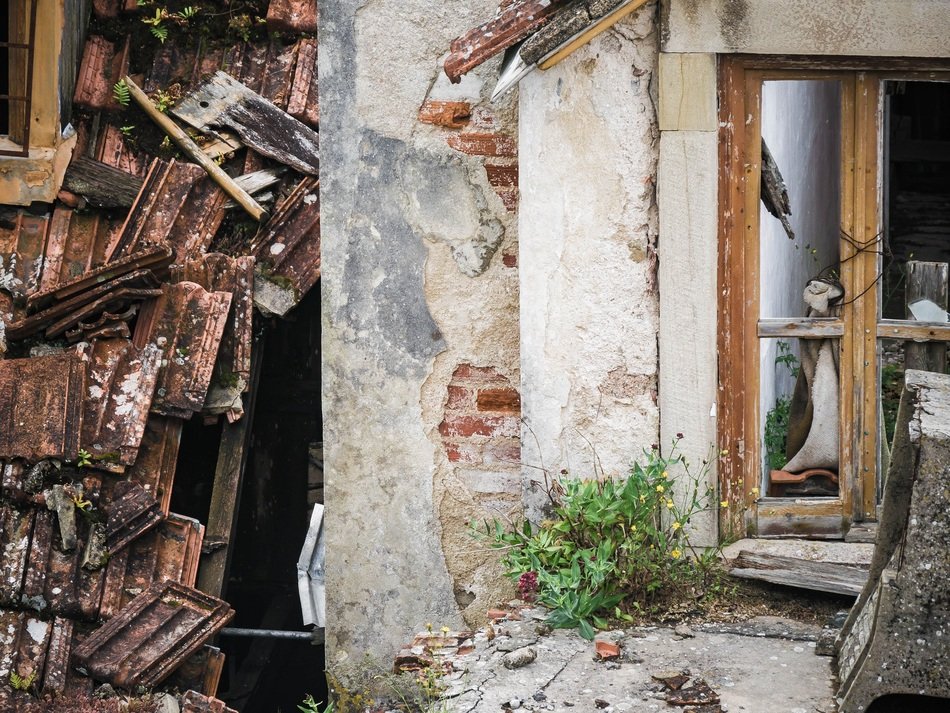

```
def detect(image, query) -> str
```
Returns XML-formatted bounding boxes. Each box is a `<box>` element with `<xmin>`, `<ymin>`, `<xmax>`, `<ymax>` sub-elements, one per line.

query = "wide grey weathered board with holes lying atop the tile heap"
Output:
<box><xmin>171</xmin><ymin>71</ymin><xmax>320</xmax><ymax>175</ymax></box>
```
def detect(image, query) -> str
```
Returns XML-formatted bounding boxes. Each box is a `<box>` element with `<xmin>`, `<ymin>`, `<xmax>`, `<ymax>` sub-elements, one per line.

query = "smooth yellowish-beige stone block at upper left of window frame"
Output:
<box><xmin>659</xmin><ymin>53</ymin><xmax>718</xmax><ymax>131</ymax></box>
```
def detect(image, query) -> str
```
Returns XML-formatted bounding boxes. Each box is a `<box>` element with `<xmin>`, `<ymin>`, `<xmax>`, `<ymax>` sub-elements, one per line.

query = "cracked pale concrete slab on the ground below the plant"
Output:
<box><xmin>446</xmin><ymin>618</ymin><xmax>834</xmax><ymax>713</ymax></box>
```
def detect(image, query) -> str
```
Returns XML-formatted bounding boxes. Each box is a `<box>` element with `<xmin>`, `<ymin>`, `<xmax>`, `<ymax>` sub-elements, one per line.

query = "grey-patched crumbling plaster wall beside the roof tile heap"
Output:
<box><xmin>319</xmin><ymin>0</ymin><xmax>519</xmax><ymax>670</ymax></box>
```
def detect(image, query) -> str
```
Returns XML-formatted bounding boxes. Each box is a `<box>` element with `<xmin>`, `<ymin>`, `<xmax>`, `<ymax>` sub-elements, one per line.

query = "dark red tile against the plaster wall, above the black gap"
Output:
<box><xmin>250</xmin><ymin>178</ymin><xmax>320</xmax><ymax>315</ymax></box>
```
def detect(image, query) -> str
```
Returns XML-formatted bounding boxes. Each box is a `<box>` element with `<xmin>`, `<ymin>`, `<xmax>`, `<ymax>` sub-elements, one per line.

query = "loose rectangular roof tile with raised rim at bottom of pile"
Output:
<box><xmin>74</xmin><ymin>581</ymin><xmax>234</xmax><ymax>688</ymax></box>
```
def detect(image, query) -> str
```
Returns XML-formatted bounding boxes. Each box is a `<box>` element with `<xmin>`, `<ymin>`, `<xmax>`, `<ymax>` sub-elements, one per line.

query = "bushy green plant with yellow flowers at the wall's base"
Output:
<box><xmin>477</xmin><ymin>437</ymin><xmax>715</xmax><ymax>639</ymax></box>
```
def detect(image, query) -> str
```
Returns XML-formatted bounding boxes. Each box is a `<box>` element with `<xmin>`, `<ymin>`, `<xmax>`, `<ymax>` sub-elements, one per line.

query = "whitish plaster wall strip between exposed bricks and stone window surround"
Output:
<box><xmin>519</xmin><ymin>4</ymin><xmax>659</xmax><ymax>518</ymax></box>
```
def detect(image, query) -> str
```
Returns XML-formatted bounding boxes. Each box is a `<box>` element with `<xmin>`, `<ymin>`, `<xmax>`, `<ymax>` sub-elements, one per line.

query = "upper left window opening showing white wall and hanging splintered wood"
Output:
<box><xmin>759</xmin><ymin>80</ymin><xmax>841</xmax><ymax>317</ymax></box>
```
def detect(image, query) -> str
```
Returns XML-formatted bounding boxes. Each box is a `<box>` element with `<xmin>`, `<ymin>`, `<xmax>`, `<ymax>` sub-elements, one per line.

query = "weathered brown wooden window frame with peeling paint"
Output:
<box><xmin>717</xmin><ymin>55</ymin><xmax>950</xmax><ymax>538</ymax></box>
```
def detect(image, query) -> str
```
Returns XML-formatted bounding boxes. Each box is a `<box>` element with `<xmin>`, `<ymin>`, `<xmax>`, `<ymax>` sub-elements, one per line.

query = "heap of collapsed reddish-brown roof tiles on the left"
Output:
<box><xmin>0</xmin><ymin>0</ymin><xmax>320</xmax><ymax>713</ymax></box>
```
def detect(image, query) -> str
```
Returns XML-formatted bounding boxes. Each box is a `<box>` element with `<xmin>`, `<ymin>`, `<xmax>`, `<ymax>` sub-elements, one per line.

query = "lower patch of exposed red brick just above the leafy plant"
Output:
<box><xmin>439</xmin><ymin>364</ymin><xmax>521</xmax><ymax>493</ymax></box>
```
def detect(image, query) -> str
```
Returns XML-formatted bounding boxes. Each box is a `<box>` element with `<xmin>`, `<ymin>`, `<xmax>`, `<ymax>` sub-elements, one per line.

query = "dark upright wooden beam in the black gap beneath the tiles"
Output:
<box><xmin>197</xmin><ymin>333</ymin><xmax>265</xmax><ymax>597</ymax></box>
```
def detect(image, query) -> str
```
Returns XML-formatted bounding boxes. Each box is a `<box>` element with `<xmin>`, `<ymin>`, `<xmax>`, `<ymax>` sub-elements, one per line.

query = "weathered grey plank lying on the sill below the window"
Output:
<box><xmin>729</xmin><ymin>550</ymin><xmax>868</xmax><ymax>597</ymax></box>
